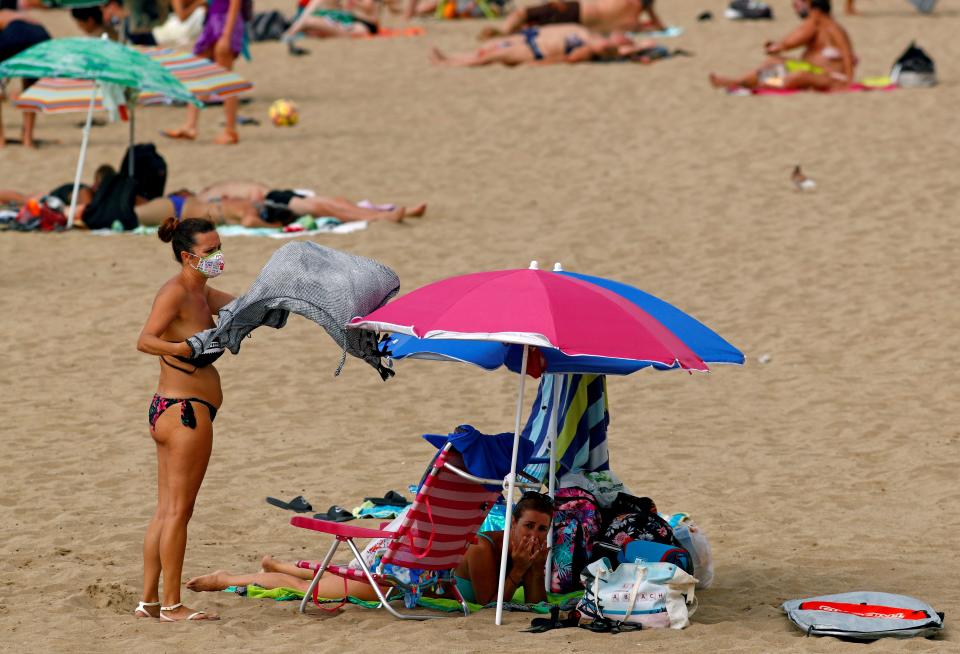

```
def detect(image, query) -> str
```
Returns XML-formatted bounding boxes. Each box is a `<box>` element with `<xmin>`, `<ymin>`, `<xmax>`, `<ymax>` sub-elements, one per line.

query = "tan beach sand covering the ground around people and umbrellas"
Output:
<box><xmin>0</xmin><ymin>0</ymin><xmax>960</xmax><ymax>654</ymax></box>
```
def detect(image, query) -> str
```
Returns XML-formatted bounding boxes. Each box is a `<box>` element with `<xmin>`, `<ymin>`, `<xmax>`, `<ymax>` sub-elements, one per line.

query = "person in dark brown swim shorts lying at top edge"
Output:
<box><xmin>480</xmin><ymin>0</ymin><xmax>664</xmax><ymax>39</ymax></box>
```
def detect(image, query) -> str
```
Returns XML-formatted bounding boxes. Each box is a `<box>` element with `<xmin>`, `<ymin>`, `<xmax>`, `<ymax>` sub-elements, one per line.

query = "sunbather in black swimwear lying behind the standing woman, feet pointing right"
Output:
<box><xmin>197</xmin><ymin>181</ymin><xmax>427</xmax><ymax>222</ymax></box>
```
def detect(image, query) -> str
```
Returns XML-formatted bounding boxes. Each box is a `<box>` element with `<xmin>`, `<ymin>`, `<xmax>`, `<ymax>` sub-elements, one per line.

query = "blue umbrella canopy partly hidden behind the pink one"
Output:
<box><xmin>383</xmin><ymin>272</ymin><xmax>744</xmax><ymax>375</ymax></box>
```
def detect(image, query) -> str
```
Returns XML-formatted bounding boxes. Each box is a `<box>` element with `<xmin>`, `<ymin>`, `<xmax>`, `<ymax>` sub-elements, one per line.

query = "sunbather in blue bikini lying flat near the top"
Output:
<box><xmin>430</xmin><ymin>23</ymin><xmax>657</xmax><ymax>66</ymax></box>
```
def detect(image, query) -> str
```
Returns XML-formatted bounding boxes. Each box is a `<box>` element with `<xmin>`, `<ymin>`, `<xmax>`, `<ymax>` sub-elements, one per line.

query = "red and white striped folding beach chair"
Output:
<box><xmin>290</xmin><ymin>443</ymin><xmax>502</xmax><ymax>620</ymax></box>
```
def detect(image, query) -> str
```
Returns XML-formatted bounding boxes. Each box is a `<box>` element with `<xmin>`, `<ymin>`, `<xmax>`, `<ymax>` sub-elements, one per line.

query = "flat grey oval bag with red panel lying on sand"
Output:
<box><xmin>783</xmin><ymin>591</ymin><xmax>943</xmax><ymax>640</ymax></box>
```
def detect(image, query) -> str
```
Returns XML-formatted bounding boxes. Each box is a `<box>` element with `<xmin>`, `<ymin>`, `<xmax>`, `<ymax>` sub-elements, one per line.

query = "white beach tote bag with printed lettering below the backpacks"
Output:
<box><xmin>577</xmin><ymin>558</ymin><xmax>697</xmax><ymax>629</ymax></box>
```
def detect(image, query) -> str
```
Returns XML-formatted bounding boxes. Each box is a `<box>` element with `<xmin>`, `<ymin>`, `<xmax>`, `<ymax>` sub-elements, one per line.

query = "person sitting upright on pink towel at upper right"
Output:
<box><xmin>710</xmin><ymin>0</ymin><xmax>857</xmax><ymax>91</ymax></box>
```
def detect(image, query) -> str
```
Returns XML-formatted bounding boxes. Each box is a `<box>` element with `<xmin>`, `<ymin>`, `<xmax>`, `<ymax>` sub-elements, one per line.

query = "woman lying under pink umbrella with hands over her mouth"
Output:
<box><xmin>187</xmin><ymin>493</ymin><xmax>553</xmax><ymax>604</ymax></box>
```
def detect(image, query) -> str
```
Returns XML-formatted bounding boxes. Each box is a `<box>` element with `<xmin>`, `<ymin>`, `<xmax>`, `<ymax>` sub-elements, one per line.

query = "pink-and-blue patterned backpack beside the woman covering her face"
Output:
<box><xmin>550</xmin><ymin>488</ymin><xmax>600</xmax><ymax>593</ymax></box>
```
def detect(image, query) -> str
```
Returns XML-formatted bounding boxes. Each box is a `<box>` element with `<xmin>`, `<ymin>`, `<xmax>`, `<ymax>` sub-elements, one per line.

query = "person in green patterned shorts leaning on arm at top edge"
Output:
<box><xmin>280</xmin><ymin>0</ymin><xmax>380</xmax><ymax>54</ymax></box>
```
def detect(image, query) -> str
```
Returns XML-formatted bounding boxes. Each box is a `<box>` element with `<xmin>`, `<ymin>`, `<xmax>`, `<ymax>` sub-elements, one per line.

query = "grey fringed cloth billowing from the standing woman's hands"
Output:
<box><xmin>188</xmin><ymin>241</ymin><xmax>400</xmax><ymax>379</ymax></box>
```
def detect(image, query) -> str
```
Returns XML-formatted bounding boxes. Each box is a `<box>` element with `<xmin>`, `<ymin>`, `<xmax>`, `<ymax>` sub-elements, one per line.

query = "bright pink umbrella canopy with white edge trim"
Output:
<box><xmin>349</xmin><ymin>269</ymin><xmax>708</xmax><ymax>371</ymax></box>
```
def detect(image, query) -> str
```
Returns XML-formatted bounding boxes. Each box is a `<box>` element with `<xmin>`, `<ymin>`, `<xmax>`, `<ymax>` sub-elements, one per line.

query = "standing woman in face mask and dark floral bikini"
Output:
<box><xmin>135</xmin><ymin>218</ymin><xmax>233</xmax><ymax>622</ymax></box>
